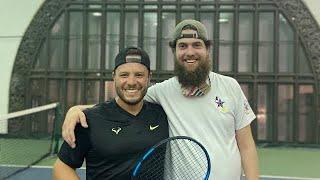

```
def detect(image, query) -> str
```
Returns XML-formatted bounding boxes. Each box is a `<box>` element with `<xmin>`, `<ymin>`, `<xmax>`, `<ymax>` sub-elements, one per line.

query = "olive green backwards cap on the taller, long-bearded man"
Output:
<box><xmin>173</xmin><ymin>19</ymin><xmax>208</xmax><ymax>41</ymax></box>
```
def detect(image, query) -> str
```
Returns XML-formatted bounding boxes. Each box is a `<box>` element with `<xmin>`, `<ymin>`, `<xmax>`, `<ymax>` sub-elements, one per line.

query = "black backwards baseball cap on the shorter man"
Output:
<box><xmin>113</xmin><ymin>47</ymin><xmax>150</xmax><ymax>71</ymax></box>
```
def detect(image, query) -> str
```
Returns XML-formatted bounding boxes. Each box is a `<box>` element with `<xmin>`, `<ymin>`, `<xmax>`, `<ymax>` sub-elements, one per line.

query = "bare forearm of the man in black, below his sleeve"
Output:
<box><xmin>52</xmin><ymin>159</ymin><xmax>80</xmax><ymax>180</ymax></box>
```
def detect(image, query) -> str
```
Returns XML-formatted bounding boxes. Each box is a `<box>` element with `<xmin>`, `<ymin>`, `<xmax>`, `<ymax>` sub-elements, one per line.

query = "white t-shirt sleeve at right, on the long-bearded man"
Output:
<box><xmin>234</xmin><ymin>80</ymin><xmax>256</xmax><ymax>130</ymax></box>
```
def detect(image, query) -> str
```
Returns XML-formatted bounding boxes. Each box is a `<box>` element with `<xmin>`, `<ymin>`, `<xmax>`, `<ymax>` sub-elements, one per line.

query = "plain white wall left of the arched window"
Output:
<box><xmin>0</xmin><ymin>0</ymin><xmax>44</xmax><ymax>133</ymax></box>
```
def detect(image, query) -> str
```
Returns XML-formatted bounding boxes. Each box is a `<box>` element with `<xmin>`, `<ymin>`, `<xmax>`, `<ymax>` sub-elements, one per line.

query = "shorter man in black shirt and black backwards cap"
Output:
<box><xmin>53</xmin><ymin>47</ymin><xmax>169</xmax><ymax>180</ymax></box>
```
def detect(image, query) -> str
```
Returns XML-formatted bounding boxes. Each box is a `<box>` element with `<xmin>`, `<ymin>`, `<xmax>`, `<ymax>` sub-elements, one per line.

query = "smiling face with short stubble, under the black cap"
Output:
<box><xmin>113</xmin><ymin>63</ymin><xmax>150</xmax><ymax>105</ymax></box>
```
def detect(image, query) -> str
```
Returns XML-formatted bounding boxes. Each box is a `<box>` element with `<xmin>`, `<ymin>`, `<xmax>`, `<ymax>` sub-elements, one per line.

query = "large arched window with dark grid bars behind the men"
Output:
<box><xmin>10</xmin><ymin>0</ymin><xmax>320</xmax><ymax>143</ymax></box>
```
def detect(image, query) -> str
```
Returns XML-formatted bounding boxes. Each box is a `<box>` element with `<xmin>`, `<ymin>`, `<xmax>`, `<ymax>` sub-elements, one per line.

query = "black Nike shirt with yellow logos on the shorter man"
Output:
<box><xmin>58</xmin><ymin>100</ymin><xmax>169</xmax><ymax>180</ymax></box>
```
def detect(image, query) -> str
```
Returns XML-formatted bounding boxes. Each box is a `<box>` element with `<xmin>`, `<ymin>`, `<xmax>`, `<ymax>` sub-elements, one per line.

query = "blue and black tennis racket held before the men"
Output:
<box><xmin>131</xmin><ymin>136</ymin><xmax>211</xmax><ymax>180</ymax></box>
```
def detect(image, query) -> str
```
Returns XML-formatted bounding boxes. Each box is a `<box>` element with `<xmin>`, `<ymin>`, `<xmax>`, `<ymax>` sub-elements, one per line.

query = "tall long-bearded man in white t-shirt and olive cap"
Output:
<box><xmin>62</xmin><ymin>19</ymin><xmax>259</xmax><ymax>180</ymax></box>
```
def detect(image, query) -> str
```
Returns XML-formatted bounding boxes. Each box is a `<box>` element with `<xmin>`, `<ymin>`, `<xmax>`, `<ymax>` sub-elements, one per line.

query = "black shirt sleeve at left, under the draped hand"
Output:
<box><xmin>58</xmin><ymin>125</ymin><xmax>90</xmax><ymax>168</ymax></box>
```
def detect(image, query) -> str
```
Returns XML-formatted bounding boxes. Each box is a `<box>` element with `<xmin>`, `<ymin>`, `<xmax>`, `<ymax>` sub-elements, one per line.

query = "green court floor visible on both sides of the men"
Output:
<box><xmin>0</xmin><ymin>138</ymin><xmax>320</xmax><ymax>178</ymax></box>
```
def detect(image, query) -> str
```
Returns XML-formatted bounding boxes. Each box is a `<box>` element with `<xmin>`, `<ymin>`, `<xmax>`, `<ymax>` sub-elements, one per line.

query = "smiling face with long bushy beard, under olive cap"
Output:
<box><xmin>175</xmin><ymin>29</ymin><xmax>211</xmax><ymax>86</ymax></box>
